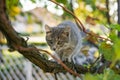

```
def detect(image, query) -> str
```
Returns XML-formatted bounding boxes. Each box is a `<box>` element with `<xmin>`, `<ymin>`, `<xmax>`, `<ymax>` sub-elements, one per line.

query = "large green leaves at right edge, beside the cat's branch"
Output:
<box><xmin>99</xmin><ymin>24</ymin><xmax>120</xmax><ymax>62</ymax></box>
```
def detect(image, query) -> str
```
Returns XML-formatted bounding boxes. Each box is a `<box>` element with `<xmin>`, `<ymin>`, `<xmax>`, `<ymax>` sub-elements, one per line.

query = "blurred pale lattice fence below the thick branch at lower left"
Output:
<box><xmin>0</xmin><ymin>50</ymin><xmax>80</xmax><ymax>80</ymax></box>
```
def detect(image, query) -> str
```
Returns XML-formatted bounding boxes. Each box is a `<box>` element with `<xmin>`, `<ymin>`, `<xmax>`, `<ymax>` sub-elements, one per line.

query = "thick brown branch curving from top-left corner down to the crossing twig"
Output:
<box><xmin>0</xmin><ymin>0</ymin><xmax>68</xmax><ymax>72</ymax></box>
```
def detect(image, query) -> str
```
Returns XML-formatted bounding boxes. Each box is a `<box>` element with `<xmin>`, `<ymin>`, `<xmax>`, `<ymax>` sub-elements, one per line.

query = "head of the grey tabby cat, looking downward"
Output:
<box><xmin>45</xmin><ymin>25</ymin><xmax>70</xmax><ymax>52</ymax></box>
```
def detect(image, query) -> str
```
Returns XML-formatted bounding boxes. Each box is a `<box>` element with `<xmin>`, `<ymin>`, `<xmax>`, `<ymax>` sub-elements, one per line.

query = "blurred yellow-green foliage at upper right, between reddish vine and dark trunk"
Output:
<box><xmin>75</xmin><ymin>0</ymin><xmax>106</xmax><ymax>24</ymax></box>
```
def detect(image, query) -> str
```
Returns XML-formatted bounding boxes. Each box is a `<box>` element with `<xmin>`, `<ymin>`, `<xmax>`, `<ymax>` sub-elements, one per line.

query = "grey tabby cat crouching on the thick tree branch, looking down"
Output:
<box><xmin>45</xmin><ymin>21</ymin><xmax>82</xmax><ymax>62</ymax></box>
